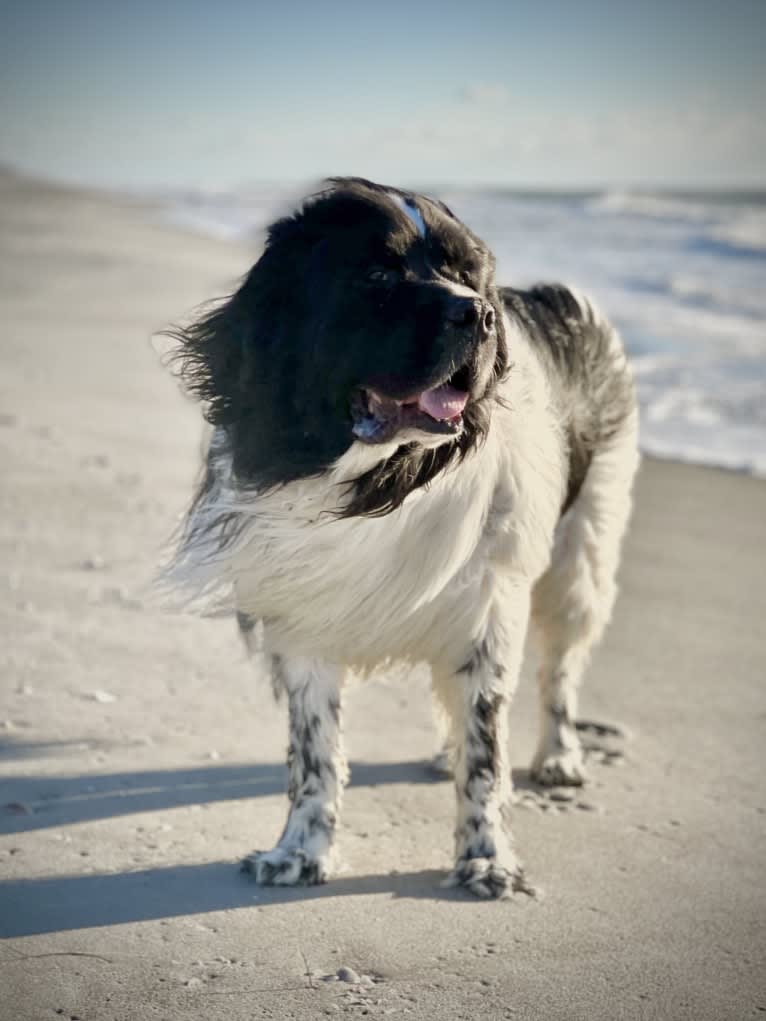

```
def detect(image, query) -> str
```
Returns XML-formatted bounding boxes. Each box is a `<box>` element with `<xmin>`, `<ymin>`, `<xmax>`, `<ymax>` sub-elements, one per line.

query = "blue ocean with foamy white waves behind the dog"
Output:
<box><xmin>163</xmin><ymin>188</ymin><xmax>766</xmax><ymax>477</ymax></box>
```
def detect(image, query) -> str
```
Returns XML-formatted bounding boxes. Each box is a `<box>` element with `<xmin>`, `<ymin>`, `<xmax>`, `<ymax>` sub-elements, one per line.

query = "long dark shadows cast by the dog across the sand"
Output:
<box><xmin>0</xmin><ymin>746</ymin><xmax>516</xmax><ymax>938</ymax></box>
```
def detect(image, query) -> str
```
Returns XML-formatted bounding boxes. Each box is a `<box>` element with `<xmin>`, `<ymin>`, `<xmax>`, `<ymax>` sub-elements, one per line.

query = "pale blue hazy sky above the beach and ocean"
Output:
<box><xmin>0</xmin><ymin>0</ymin><xmax>766</xmax><ymax>190</ymax></box>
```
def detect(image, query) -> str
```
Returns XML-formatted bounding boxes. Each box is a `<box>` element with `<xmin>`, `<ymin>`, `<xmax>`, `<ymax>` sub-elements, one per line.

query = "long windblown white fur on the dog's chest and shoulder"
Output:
<box><xmin>167</xmin><ymin>330</ymin><xmax>563</xmax><ymax>669</ymax></box>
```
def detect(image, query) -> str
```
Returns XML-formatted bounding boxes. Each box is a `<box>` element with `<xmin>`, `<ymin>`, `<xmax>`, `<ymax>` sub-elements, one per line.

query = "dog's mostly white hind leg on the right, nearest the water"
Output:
<box><xmin>531</xmin><ymin>415</ymin><xmax>638</xmax><ymax>786</ymax></box>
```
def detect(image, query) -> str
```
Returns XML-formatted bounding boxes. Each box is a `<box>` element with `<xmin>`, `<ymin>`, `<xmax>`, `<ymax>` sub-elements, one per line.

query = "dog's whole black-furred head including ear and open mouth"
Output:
<box><xmin>171</xmin><ymin>178</ymin><xmax>508</xmax><ymax>516</ymax></box>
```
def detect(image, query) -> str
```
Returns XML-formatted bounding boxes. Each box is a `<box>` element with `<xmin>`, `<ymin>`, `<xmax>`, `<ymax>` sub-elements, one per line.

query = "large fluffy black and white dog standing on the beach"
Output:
<box><xmin>170</xmin><ymin>178</ymin><xmax>637</xmax><ymax>896</ymax></box>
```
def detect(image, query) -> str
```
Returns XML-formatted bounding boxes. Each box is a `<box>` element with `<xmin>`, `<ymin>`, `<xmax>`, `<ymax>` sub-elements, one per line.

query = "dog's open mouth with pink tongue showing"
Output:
<box><xmin>351</xmin><ymin>366</ymin><xmax>471</xmax><ymax>443</ymax></box>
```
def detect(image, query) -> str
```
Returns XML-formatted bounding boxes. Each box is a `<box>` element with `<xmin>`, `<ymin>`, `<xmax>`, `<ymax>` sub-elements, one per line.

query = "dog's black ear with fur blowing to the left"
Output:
<box><xmin>167</xmin><ymin>214</ymin><xmax>347</xmax><ymax>486</ymax></box>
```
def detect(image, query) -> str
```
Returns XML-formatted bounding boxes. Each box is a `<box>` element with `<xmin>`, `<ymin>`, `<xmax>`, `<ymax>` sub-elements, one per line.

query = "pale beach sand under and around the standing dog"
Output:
<box><xmin>0</xmin><ymin>174</ymin><xmax>766</xmax><ymax>1021</ymax></box>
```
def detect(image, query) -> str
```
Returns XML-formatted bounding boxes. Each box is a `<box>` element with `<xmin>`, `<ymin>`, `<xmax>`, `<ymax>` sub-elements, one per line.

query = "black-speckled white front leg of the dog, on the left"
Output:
<box><xmin>242</xmin><ymin>657</ymin><xmax>347</xmax><ymax>886</ymax></box>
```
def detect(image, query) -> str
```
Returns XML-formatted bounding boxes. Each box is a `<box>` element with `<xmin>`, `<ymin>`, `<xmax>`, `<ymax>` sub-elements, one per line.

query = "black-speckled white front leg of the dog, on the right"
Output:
<box><xmin>434</xmin><ymin>588</ymin><xmax>531</xmax><ymax>897</ymax></box>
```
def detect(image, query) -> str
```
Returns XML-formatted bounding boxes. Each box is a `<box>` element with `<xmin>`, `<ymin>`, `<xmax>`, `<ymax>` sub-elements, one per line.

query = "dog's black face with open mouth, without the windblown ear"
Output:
<box><xmin>293</xmin><ymin>189</ymin><xmax>501</xmax><ymax>446</ymax></box>
